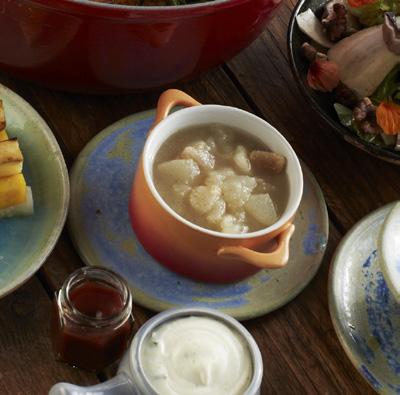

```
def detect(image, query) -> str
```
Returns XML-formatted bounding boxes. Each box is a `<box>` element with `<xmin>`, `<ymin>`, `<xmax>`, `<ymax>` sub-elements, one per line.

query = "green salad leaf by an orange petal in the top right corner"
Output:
<box><xmin>349</xmin><ymin>0</ymin><xmax>400</xmax><ymax>26</ymax></box>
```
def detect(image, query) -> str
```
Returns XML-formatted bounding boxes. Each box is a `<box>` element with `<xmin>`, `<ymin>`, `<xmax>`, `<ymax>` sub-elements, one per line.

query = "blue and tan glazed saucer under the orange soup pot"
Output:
<box><xmin>69</xmin><ymin>111</ymin><xmax>328</xmax><ymax>320</ymax></box>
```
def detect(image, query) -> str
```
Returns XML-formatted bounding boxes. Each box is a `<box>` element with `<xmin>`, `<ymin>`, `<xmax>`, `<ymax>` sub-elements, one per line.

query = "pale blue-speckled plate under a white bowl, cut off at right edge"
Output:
<box><xmin>329</xmin><ymin>205</ymin><xmax>400</xmax><ymax>394</ymax></box>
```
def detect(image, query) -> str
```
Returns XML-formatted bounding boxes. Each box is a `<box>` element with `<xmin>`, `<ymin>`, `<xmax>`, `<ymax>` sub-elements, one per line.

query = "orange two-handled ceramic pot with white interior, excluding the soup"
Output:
<box><xmin>129</xmin><ymin>89</ymin><xmax>303</xmax><ymax>283</ymax></box>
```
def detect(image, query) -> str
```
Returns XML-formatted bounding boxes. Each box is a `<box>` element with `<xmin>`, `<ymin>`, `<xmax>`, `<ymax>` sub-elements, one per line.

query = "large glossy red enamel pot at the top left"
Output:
<box><xmin>0</xmin><ymin>0</ymin><xmax>281</xmax><ymax>93</ymax></box>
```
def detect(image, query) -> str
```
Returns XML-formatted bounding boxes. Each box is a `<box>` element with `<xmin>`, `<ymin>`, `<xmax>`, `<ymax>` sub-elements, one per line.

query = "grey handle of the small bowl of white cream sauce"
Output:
<box><xmin>49</xmin><ymin>373</ymin><xmax>138</xmax><ymax>395</ymax></box>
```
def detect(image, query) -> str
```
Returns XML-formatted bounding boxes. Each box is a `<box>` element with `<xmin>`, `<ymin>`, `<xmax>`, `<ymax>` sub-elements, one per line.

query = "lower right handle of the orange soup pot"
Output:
<box><xmin>217</xmin><ymin>223</ymin><xmax>294</xmax><ymax>269</ymax></box>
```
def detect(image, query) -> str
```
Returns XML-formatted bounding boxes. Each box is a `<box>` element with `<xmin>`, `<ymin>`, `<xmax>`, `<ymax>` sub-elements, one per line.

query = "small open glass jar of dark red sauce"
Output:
<box><xmin>53</xmin><ymin>267</ymin><xmax>134</xmax><ymax>371</ymax></box>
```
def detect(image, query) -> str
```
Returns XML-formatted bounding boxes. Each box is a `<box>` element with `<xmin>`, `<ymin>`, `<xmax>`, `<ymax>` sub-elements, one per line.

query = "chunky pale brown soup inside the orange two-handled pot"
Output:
<box><xmin>153</xmin><ymin>124</ymin><xmax>289</xmax><ymax>233</ymax></box>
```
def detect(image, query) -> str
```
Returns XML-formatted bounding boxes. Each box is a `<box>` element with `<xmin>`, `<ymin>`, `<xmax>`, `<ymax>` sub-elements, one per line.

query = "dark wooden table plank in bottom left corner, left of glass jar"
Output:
<box><xmin>0</xmin><ymin>277</ymin><xmax>98</xmax><ymax>395</ymax></box>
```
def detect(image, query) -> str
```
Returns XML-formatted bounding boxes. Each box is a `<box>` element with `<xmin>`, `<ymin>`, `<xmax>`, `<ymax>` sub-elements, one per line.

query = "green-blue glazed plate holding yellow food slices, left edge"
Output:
<box><xmin>0</xmin><ymin>85</ymin><xmax>69</xmax><ymax>297</ymax></box>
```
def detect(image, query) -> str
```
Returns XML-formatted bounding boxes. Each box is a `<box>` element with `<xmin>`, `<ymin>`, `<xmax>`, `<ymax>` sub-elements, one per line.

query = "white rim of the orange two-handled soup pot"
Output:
<box><xmin>141</xmin><ymin>104</ymin><xmax>303</xmax><ymax>240</ymax></box>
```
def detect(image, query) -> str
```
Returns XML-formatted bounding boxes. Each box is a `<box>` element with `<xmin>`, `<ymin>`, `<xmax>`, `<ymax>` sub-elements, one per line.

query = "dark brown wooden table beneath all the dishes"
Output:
<box><xmin>0</xmin><ymin>0</ymin><xmax>390</xmax><ymax>395</ymax></box>
